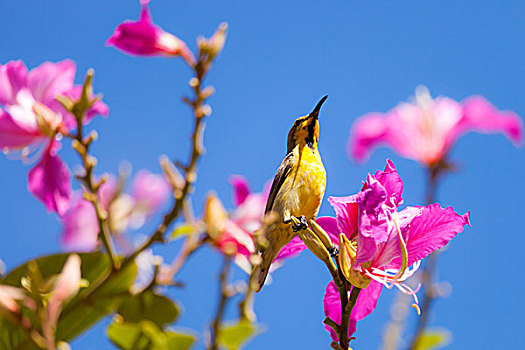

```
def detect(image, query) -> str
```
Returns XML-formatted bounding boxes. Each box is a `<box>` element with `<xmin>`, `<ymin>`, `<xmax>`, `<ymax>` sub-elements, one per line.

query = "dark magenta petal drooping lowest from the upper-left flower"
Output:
<box><xmin>28</xmin><ymin>142</ymin><xmax>71</xmax><ymax>215</ymax></box>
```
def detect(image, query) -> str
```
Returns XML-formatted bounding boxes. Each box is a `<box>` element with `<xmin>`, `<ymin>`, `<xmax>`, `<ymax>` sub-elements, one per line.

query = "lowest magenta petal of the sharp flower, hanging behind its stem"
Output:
<box><xmin>323</xmin><ymin>281</ymin><xmax>383</xmax><ymax>341</ymax></box>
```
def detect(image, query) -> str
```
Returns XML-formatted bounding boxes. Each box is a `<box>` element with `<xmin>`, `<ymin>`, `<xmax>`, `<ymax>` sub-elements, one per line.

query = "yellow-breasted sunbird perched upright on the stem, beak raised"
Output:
<box><xmin>252</xmin><ymin>96</ymin><xmax>328</xmax><ymax>292</ymax></box>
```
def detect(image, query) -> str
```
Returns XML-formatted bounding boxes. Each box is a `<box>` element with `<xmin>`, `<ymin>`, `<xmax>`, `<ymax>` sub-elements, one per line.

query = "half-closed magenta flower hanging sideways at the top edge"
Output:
<box><xmin>106</xmin><ymin>0</ymin><xmax>195</xmax><ymax>66</ymax></box>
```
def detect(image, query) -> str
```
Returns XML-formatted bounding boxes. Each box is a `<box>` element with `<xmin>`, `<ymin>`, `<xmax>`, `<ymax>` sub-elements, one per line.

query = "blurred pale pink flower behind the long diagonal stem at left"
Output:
<box><xmin>61</xmin><ymin>170</ymin><xmax>170</xmax><ymax>252</ymax></box>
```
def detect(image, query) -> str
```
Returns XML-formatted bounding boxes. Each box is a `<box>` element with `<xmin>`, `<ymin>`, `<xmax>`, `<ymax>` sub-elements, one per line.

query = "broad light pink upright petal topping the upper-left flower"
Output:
<box><xmin>28</xmin><ymin>60</ymin><xmax>76</xmax><ymax>104</ymax></box>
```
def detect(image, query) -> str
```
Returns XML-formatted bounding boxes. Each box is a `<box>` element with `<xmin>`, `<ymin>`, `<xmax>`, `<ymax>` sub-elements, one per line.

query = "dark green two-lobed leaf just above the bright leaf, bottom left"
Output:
<box><xmin>117</xmin><ymin>290</ymin><xmax>179</xmax><ymax>327</ymax></box>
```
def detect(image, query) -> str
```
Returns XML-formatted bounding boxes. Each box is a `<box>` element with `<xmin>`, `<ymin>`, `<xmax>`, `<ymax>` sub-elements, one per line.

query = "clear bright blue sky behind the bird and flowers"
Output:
<box><xmin>0</xmin><ymin>0</ymin><xmax>525</xmax><ymax>349</ymax></box>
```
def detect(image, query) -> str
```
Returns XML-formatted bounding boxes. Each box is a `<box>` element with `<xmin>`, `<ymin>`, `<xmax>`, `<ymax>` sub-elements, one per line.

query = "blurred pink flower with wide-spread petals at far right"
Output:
<box><xmin>348</xmin><ymin>87</ymin><xmax>523</xmax><ymax>166</ymax></box>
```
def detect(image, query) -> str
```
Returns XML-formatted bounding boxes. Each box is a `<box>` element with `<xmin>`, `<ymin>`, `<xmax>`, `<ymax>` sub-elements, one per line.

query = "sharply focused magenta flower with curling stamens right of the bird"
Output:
<box><xmin>317</xmin><ymin>160</ymin><xmax>470</xmax><ymax>340</ymax></box>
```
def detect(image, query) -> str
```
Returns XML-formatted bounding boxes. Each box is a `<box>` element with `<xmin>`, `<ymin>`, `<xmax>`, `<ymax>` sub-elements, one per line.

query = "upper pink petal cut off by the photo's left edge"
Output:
<box><xmin>0</xmin><ymin>60</ymin><xmax>27</xmax><ymax>105</ymax></box>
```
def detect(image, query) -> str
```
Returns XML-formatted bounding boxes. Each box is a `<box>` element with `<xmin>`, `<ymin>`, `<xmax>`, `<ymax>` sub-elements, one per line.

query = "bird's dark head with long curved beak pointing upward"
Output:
<box><xmin>286</xmin><ymin>96</ymin><xmax>328</xmax><ymax>153</ymax></box>
